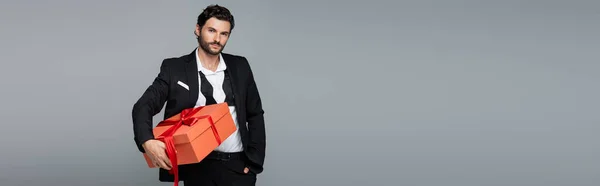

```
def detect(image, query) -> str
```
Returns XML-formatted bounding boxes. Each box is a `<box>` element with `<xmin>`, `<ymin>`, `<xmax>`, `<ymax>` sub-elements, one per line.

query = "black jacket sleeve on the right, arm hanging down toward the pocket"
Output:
<box><xmin>243</xmin><ymin>58</ymin><xmax>266</xmax><ymax>174</ymax></box>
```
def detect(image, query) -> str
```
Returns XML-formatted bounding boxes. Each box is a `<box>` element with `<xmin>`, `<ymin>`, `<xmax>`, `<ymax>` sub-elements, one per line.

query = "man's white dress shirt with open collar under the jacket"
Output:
<box><xmin>196</xmin><ymin>48</ymin><xmax>243</xmax><ymax>152</ymax></box>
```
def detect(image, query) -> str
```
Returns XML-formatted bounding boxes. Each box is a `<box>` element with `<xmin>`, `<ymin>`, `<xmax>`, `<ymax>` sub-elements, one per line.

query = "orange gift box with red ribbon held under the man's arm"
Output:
<box><xmin>144</xmin><ymin>102</ymin><xmax>236</xmax><ymax>185</ymax></box>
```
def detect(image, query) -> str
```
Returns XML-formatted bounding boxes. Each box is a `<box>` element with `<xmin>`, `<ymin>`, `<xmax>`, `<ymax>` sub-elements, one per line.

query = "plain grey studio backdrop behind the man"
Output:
<box><xmin>0</xmin><ymin>0</ymin><xmax>600</xmax><ymax>186</ymax></box>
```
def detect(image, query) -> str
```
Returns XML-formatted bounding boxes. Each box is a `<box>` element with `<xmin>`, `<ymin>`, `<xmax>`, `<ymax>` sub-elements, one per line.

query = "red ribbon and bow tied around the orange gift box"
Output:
<box><xmin>157</xmin><ymin>107</ymin><xmax>222</xmax><ymax>186</ymax></box>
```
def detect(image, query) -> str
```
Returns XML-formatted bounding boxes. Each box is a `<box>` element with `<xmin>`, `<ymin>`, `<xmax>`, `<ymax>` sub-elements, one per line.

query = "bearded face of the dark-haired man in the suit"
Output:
<box><xmin>196</xmin><ymin>17</ymin><xmax>231</xmax><ymax>55</ymax></box>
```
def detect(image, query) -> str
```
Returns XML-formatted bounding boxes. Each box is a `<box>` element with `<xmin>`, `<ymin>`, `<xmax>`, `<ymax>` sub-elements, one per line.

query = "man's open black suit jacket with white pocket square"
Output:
<box><xmin>132</xmin><ymin>51</ymin><xmax>266</xmax><ymax>181</ymax></box>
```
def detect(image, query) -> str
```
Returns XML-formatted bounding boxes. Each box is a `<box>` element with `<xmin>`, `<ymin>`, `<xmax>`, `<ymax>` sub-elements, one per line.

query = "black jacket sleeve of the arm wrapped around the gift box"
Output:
<box><xmin>132</xmin><ymin>60</ymin><xmax>170</xmax><ymax>153</ymax></box>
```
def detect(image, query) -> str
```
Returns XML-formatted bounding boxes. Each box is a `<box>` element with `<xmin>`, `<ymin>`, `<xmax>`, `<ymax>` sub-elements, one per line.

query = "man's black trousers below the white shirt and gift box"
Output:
<box><xmin>183</xmin><ymin>152</ymin><xmax>256</xmax><ymax>186</ymax></box>
